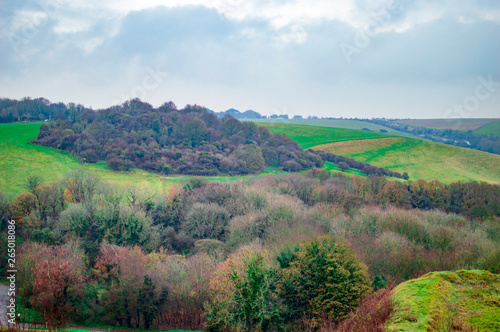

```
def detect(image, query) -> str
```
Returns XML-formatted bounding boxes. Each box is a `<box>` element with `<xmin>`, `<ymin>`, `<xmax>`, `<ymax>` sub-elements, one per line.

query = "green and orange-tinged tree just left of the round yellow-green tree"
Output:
<box><xmin>206</xmin><ymin>247</ymin><xmax>282</xmax><ymax>331</ymax></box>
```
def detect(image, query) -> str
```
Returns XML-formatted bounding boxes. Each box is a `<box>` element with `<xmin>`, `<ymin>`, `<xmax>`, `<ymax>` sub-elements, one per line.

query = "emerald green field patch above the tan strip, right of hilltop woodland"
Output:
<box><xmin>254</xmin><ymin>123</ymin><xmax>393</xmax><ymax>149</ymax></box>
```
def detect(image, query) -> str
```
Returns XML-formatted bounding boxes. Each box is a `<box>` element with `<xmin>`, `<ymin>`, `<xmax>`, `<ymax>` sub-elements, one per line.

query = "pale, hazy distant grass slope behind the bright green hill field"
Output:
<box><xmin>252</xmin><ymin>119</ymin><xmax>415</xmax><ymax>138</ymax></box>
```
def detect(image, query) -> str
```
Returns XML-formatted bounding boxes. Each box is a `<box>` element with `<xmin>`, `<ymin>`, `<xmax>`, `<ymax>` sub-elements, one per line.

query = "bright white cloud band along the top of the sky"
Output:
<box><xmin>7</xmin><ymin>0</ymin><xmax>500</xmax><ymax>52</ymax></box>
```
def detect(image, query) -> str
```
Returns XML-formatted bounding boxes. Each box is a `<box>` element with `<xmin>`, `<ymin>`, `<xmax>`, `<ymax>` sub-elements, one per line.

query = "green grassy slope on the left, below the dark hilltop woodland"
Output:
<box><xmin>0</xmin><ymin>123</ymin><xmax>247</xmax><ymax>195</ymax></box>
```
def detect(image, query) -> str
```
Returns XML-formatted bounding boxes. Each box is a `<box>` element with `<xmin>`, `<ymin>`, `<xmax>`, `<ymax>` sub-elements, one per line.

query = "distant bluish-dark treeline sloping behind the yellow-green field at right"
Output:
<box><xmin>362</xmin><ymin>119</ymin><xmax>500</xmax><ymax>154</ymax></box>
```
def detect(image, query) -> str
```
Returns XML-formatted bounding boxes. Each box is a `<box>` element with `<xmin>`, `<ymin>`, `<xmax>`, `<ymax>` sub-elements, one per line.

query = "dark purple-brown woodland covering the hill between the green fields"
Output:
<box><xmin>2</xmin><ymin>99</ymin><xmax>408</xmax><ymax>179</ymax></box>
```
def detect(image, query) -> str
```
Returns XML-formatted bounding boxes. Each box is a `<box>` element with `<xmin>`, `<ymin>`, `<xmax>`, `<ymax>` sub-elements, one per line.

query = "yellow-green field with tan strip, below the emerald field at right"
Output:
<box><xmin>314</xmin><ymin>137</ymin><xmax>500</xmax><ymax>183</ymax></box>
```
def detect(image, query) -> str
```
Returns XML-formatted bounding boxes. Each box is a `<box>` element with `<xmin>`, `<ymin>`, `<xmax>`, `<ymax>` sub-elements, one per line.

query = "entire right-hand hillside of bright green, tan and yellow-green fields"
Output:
<box><xmin>263</xmin><ymin>124</ymin><xmax>500</xmax><ymax>183</ymax></box>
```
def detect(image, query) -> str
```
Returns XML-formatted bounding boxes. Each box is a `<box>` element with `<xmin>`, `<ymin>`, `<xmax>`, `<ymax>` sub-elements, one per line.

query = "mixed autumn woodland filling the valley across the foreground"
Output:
<box><xmin>0</xmin><ymin>170</ymin><xmax>500</xmax><ymax>331</ymax></box>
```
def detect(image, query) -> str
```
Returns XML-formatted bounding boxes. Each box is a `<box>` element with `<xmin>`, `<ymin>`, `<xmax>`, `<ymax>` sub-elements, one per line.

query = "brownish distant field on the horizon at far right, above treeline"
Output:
<box><xmin>394</xmin><ymin>118</ymin><xmax>498</xmax><ymax>131</ymax></box>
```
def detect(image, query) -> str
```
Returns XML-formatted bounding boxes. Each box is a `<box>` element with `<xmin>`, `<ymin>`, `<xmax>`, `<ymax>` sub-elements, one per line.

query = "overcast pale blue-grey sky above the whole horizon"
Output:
<box><xmin>0</xmin><ymin>0</ymin><xmax>500</xmax><ymax>118</ymax></box>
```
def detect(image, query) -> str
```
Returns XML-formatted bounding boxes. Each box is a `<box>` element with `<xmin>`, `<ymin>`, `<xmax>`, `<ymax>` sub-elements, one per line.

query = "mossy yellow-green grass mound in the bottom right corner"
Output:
<box><xmin>386</xmin><ymin>270</ymin><xmax>500</xmax><ymax>331</ymax></box>
